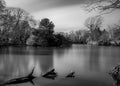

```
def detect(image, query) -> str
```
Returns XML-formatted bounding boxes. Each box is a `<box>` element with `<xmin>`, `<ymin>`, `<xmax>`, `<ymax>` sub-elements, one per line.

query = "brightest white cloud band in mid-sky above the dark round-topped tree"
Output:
<box><xmin>33</xmin><ymin>5</ymin><xmax>95</xmax><ymax>32</ymax></box>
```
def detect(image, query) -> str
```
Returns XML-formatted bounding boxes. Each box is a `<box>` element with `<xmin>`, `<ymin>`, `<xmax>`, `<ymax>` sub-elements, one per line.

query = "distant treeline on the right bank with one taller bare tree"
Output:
<box><xmin>69</xmin><ymin>16</ymin><xmax>120</xmax><ymax>46</ymax></box>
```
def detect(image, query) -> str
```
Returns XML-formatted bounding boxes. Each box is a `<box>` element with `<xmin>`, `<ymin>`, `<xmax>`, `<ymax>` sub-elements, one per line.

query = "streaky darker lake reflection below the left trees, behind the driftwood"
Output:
<box><xmin>0</xmin><ymin>47</ymin><xmax>53</xmax><ymax>79</ymax></box>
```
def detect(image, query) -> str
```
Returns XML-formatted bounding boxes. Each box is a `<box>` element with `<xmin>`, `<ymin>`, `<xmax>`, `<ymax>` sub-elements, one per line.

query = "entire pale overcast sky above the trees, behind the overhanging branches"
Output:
<box><xmin>5</xmin><ymin>0</ymin><xmax>120</xmax><ymax>32</ymax></box>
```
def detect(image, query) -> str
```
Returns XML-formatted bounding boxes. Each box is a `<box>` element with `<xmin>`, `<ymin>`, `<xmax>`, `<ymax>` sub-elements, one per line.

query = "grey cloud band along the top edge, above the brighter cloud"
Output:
<box><xmin>5</xmin><ymin>0</ymin><xmax>92</xmax><ymax>13</ymax></box>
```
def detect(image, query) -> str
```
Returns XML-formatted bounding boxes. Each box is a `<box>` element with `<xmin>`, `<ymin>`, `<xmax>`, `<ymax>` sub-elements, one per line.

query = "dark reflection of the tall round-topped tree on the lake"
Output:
<box><xmin>28</xmin><ymin>47</ymin><xmax>53</xmax><ymax>74</ymax></box>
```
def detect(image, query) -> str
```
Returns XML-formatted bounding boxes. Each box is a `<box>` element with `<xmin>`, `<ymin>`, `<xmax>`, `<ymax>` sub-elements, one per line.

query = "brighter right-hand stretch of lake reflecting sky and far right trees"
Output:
<box><xmin>54</xmin><ymin>45</ymin><xmax>120</xmax><ymax>75</ymax></box>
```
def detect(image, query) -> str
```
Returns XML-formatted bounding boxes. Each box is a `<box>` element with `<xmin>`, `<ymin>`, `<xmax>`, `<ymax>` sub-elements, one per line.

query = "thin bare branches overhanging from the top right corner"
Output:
<box><xmin>86</xmin><ymin>0</ymin><xmax>120</xmax><ymax>13</ymax></box>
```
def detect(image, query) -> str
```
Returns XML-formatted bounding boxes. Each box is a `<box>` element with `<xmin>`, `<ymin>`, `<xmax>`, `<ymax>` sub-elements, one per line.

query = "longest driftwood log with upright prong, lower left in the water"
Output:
<box><xmin>2</xmin><ymin>68</ymin><xmax>36</xmax><ymax>86</ymax></box>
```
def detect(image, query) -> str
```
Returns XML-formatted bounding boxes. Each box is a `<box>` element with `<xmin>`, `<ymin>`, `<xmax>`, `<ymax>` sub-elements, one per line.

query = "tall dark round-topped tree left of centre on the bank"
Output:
<box><xmin>33</xmin><ymin>18</ymin><xmax>55</xmax><ymax>46</ymax></box>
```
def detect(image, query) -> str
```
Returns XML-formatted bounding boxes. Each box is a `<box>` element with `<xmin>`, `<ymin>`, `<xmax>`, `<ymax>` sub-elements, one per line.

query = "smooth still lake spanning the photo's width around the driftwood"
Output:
<box><xmin>0</xmin><ymin>45</ymin><xmax>120</xmax><ymax>86</ymax></box>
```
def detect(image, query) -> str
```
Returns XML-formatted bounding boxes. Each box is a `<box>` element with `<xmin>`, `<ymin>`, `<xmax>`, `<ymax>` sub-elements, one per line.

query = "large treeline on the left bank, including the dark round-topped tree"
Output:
<box><xmin>0</xmin><ymin>0</ymin><xmax>71</xmax><ymax>47</ymax></box>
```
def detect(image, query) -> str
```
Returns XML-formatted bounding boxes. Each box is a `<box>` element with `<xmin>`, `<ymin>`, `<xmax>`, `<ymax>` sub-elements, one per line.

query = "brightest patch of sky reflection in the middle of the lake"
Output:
<box><xmin>54</xmin><ymin>45</ymin><xmax>88</xmax><ymax>75</ymax></box>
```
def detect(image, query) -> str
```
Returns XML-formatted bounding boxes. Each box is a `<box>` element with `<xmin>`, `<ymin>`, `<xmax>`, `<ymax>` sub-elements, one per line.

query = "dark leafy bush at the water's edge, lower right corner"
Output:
<box><xmin>109</xmin><ymin>65</ymin><xmax>120</xmax><ymax>86</ymax></box>
